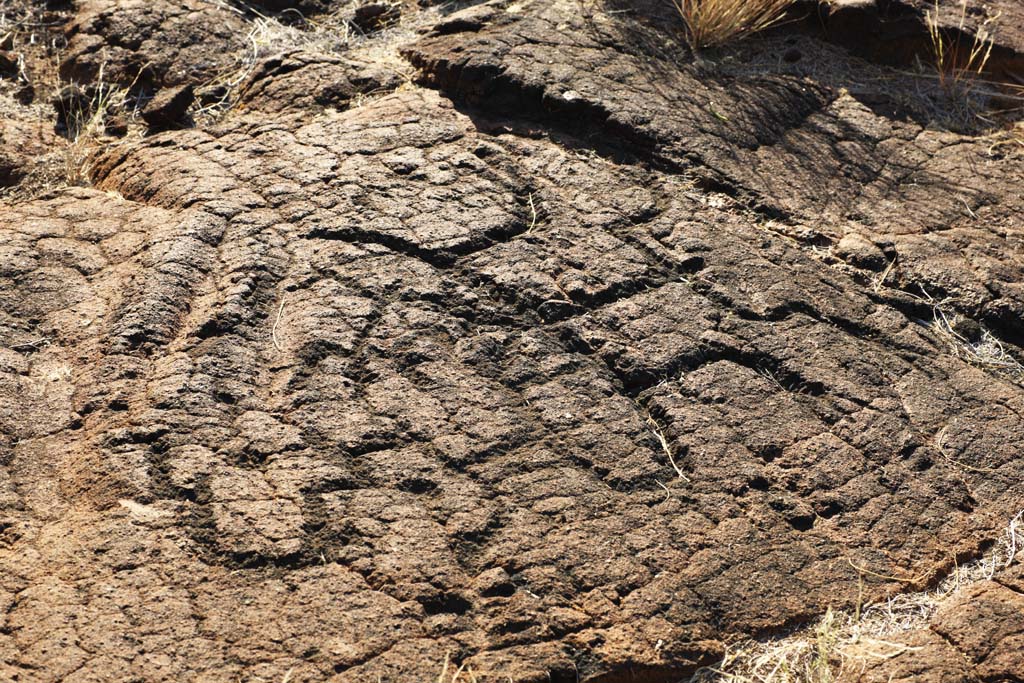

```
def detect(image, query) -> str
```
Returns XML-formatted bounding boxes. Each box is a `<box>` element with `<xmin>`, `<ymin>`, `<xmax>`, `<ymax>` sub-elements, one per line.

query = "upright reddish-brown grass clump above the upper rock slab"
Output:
<box><xmin>676</xmin><ymin>0</ymin><xmax>793</xmax><ymax>50</ymax></box>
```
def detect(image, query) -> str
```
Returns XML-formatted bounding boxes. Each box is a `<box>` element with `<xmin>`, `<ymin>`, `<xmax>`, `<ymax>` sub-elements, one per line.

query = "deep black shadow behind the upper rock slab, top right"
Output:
<box><xmin>593</xmin><ymin>0</ymin><xmax>1024</xmax><ymax>134</ymax></box>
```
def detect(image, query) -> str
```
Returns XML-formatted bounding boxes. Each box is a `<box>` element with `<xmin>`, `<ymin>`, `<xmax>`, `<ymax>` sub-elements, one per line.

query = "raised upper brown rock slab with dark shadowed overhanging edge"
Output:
<box><xmin>408</xmin><ymin>4</ymin><xmax>1024</xmax><ymax>340</ymax></box>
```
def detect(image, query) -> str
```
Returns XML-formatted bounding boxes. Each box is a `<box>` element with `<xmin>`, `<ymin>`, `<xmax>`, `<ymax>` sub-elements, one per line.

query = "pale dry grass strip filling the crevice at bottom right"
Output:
<box><xmin>689</xmin><ymin>511</ymin><xmax>1024</xmax><ymax>683</ymax></box>
